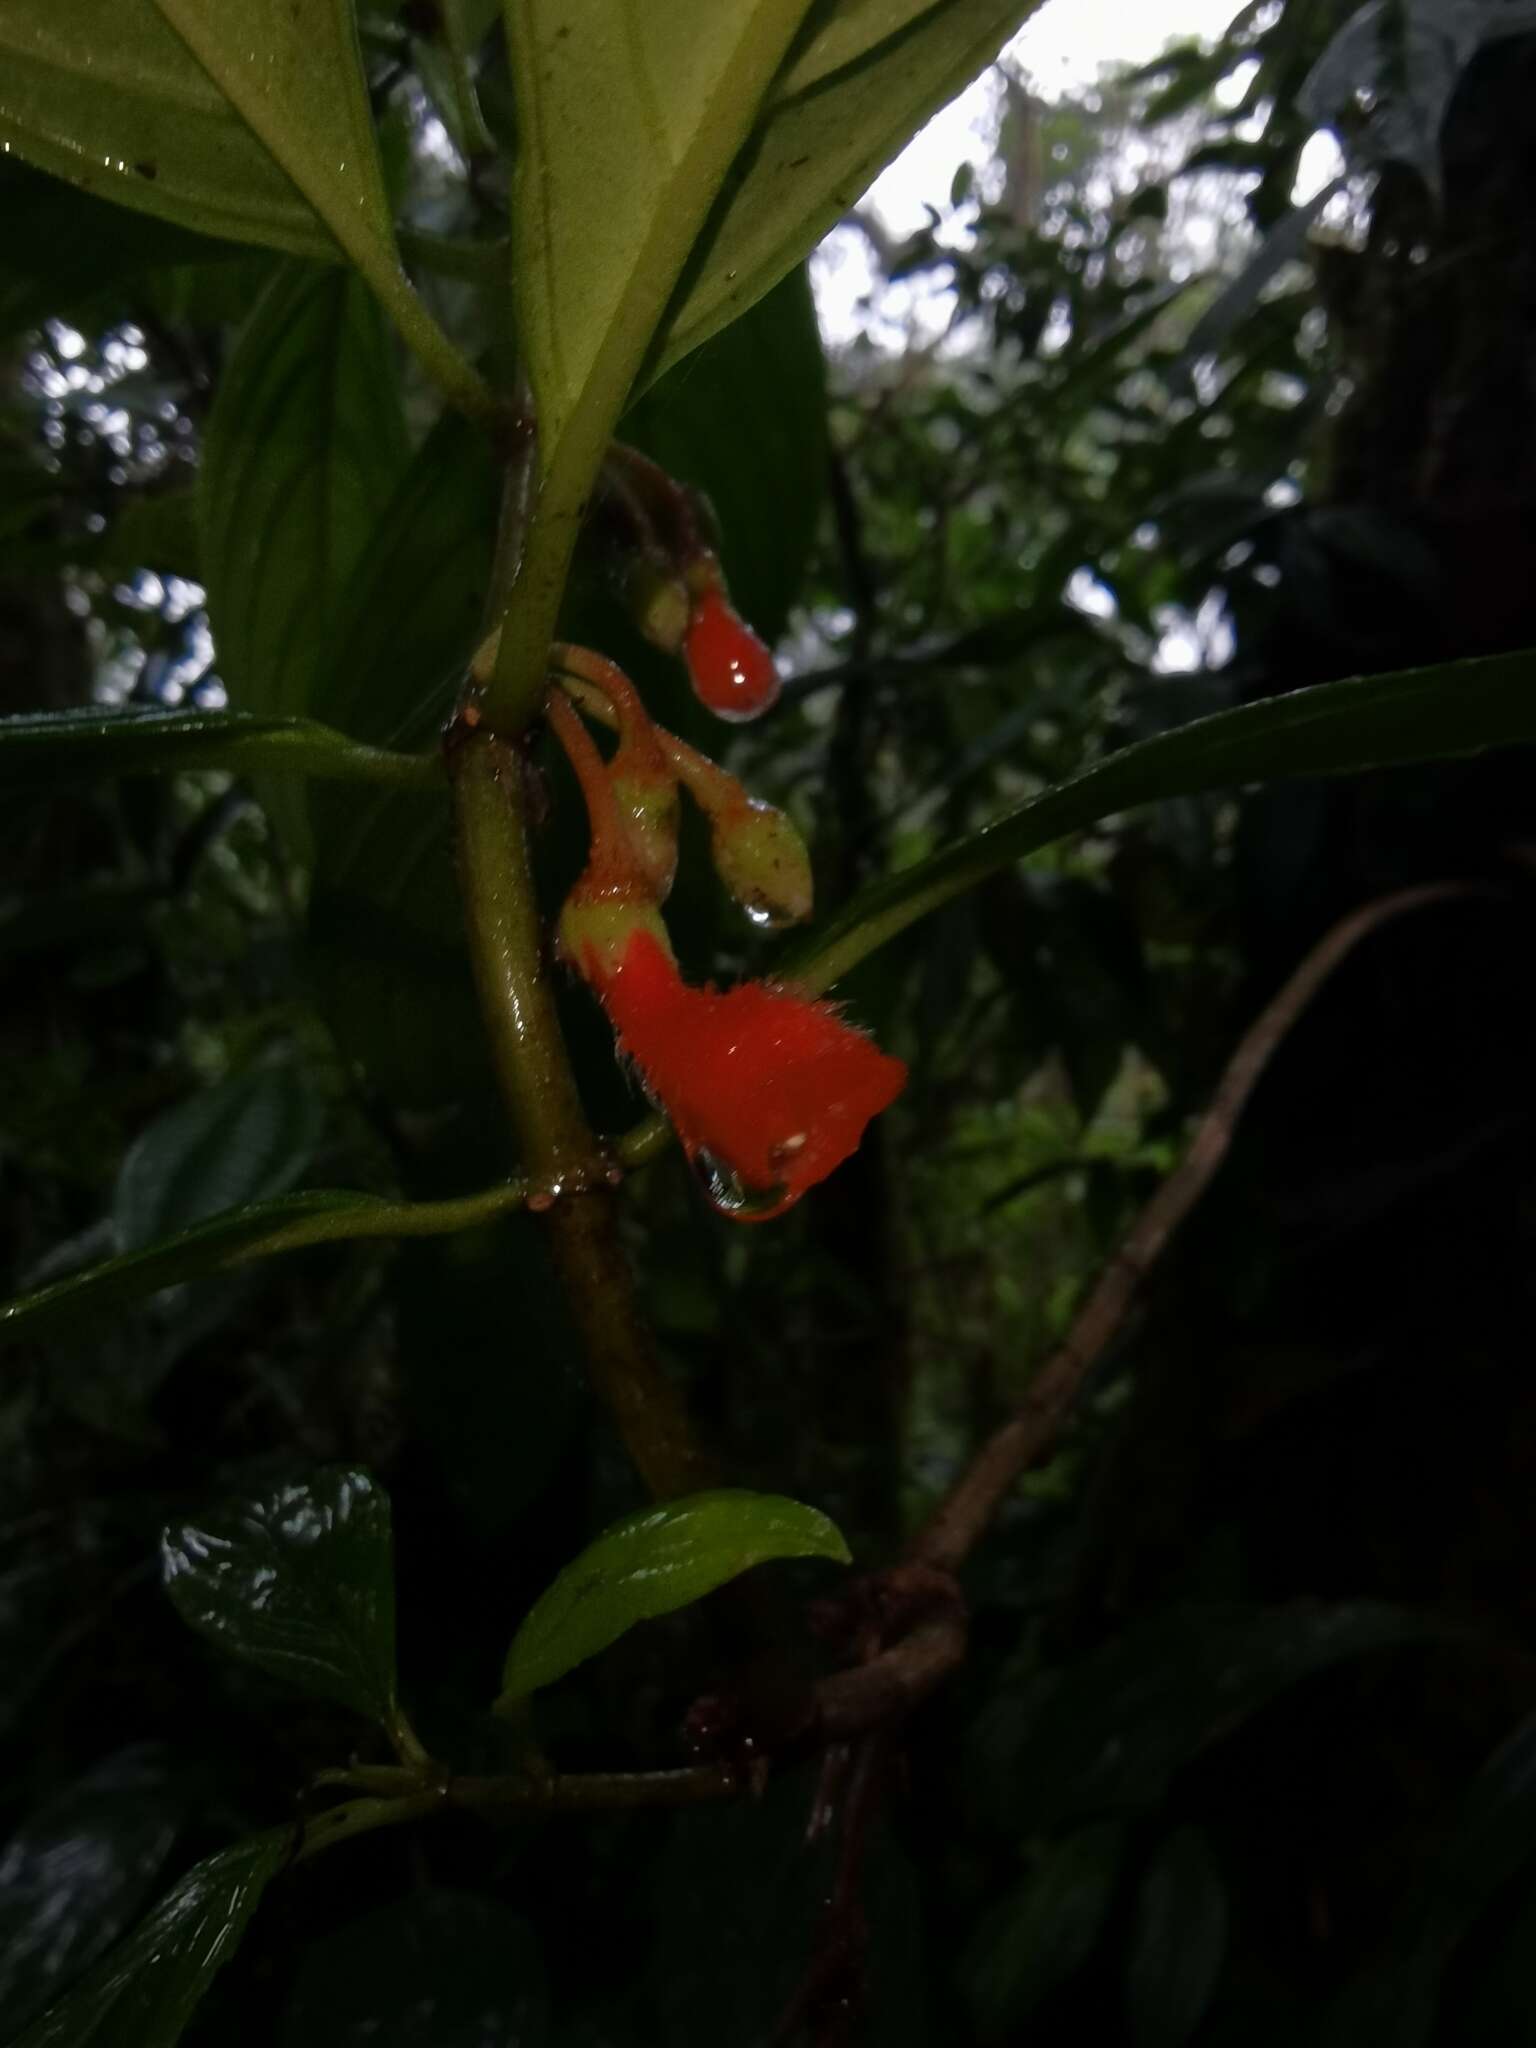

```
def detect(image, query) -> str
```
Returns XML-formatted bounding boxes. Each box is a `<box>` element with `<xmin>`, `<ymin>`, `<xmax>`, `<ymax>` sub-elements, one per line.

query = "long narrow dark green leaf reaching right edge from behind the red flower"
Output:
<box><xmin>794</xmin><ymin>653</ymin><xmax>1536</xmax><ymax>989</ymax></box>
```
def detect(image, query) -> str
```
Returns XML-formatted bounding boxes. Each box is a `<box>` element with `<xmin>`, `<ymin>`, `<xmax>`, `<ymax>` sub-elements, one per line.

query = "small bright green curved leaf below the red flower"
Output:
<box><xmin>502</xmin><ymin>1489</ymin><xmax>850</xmax><ymax>1706</ymax></box>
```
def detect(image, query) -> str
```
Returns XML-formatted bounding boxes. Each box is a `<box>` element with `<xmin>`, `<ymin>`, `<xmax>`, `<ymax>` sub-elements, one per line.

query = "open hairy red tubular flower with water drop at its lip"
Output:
<box><xmin>580</xmin><ymin>930</ymin><xmax>907</xmax><ymax>1223</ymax></box>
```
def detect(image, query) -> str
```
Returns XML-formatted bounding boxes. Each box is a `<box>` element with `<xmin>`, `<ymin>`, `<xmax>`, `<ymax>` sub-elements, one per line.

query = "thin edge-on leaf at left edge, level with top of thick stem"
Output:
<box><xmin>0</xmin><ymin>711</ymin><xmax>436</xmax><ymax>788</ymax></box>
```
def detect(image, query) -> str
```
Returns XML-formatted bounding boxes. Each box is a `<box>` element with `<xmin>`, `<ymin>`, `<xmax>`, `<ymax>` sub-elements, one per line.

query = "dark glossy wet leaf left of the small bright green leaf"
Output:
<box><xmin>162</xmin><ymin>1466</ymin><xmax>395</xmax><ymax>1722</ymax></box>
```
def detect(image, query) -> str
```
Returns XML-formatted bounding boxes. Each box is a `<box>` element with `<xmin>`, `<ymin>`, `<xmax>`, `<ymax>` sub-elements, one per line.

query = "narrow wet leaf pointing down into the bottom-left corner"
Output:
<box><xmin>12</xmin><ymin>1829</ymin><xmax>289</xmax><ymax>2048</ymax></box>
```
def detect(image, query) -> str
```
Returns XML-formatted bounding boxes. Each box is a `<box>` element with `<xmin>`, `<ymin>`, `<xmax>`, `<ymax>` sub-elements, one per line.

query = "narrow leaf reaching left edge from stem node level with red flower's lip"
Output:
<box><xmin>0</xmin><ymin>1182</ymin><xmax>524</xmax><ymax>1346</ymax></box>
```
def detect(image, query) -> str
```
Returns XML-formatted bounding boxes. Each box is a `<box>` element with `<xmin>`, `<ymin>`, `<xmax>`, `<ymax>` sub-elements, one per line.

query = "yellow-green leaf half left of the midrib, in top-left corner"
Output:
<box><xmin>0</xmin><ymin>0</ymin><xmax>336</xmax><ymax>258</ymax></box>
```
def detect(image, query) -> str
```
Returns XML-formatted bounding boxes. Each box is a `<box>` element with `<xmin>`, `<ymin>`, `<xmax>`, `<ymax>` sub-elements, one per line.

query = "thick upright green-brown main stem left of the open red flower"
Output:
<box><xmin>451</xmin><ymin>729</ymin><xmax>711</xmax><ymax>1495</ymax></box>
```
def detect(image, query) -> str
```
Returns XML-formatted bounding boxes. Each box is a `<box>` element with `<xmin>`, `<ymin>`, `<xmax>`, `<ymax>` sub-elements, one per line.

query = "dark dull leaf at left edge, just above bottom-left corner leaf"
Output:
<box><xmin>0</xmin><ymin>1747</ymin><xmax>182</xmax><ymax>2032</ymax></box>
